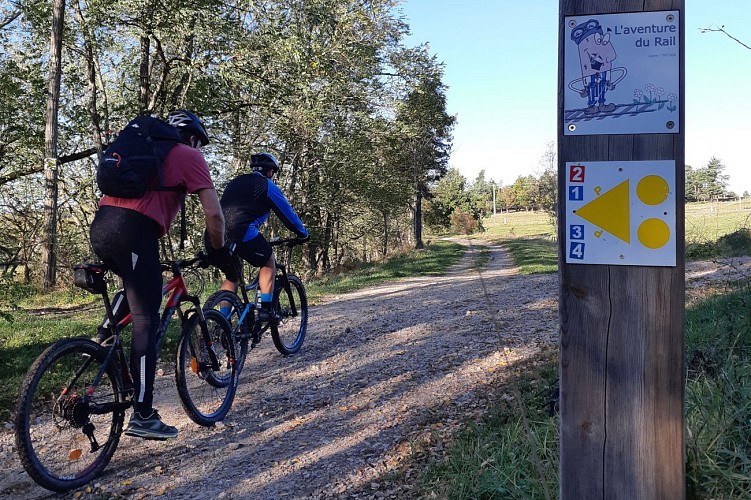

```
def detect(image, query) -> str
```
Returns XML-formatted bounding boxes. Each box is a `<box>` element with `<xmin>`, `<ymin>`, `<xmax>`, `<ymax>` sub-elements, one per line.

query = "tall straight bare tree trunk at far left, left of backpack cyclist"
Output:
<box><xmin>42</xmin><ymin>0</ymin><xmax>65</xmax><ymax>291</ymax></box>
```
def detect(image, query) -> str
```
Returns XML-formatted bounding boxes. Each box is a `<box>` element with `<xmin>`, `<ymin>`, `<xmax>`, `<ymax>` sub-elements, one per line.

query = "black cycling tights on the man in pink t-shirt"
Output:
<box><xmin>90</xmin><ymin>206</ymin><xmax>162</xmax><ymax>417</ymax></box>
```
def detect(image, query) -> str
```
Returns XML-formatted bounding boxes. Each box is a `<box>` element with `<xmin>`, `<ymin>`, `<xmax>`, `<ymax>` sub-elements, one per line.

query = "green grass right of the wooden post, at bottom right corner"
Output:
<box><xmin>686</xmin><ymin>282</ymin><xmax>751</xmax><ymax>499</ymax></box>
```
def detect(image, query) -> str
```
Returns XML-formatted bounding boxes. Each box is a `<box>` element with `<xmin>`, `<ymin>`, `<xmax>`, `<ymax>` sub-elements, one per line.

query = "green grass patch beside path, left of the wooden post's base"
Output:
<box><xmin>419</xmin><ymin>349</ymin><xmax>558</xmax><ymax>500</ymax></box>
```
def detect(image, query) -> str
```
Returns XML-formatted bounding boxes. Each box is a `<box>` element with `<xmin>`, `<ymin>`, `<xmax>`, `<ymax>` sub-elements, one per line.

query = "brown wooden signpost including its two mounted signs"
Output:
<box><xmin>558</xmin><ymin>0</ymin><xmax>685</xmax><ymax>500</ymax></box>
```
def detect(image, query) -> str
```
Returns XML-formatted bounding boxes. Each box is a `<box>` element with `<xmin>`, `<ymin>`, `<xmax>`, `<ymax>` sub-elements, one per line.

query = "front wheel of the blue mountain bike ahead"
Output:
<box><xmin>271</xmin><ymin>274</ymin><xmax>308</xmax><ymax>356</ymax></box>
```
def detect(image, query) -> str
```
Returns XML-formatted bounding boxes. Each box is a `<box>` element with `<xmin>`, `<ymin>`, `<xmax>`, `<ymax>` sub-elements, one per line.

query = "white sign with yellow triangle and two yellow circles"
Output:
<box><xmin>565</xmin><ymin>160</ymin><xmax>676</xmax><ymax>266</ymax></box>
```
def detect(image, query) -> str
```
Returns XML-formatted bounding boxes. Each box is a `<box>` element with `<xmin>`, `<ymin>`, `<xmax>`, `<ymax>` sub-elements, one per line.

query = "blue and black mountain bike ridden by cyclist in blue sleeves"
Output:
<box><xmin>203</xmin><ymin>238</ymin><xmax>308</xmax><ymax>372</ymax></box>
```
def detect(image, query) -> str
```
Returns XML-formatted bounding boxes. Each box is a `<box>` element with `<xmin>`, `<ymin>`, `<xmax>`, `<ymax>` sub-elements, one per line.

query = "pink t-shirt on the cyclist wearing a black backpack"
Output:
<box><xmin>99</xmin><ymin>144</ymin><xmax>214</xmax><ymax>236</ymax></box>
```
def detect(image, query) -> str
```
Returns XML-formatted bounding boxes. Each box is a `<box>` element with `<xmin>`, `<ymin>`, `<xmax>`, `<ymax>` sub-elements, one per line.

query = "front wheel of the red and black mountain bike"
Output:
<box><xmin>175</xmin><ymin>310</ymin><xmax>237</xmax><ymax>427</ymax></box>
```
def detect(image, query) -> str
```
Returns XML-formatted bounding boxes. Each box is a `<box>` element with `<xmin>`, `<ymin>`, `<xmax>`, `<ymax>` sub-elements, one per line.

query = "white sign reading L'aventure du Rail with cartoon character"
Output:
<box><xmin>563</xmin><ymin>10</ymin><xmax>681</xmax><ymax>135</ymax></box>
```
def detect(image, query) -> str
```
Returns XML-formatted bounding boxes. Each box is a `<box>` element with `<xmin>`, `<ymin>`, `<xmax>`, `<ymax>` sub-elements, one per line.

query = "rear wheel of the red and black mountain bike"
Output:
<box><xmin>15</xmin><ymin>338</ymin><xmax>125</xmax><ymax>492</ymax></box>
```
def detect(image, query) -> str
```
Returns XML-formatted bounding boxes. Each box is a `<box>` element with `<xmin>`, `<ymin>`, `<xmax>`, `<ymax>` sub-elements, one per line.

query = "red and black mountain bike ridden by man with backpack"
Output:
<box><xmin>15</xmin><ymin>254</ymin><xmax>239</xmax><ymax>492</ymax></box>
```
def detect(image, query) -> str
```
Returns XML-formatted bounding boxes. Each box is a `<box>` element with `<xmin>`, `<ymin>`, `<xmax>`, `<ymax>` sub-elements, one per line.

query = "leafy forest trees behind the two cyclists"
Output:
<box><xmin>0</xmin><ymin>0</ymin><xmax>456</xmax><ymax>290</ymax></box>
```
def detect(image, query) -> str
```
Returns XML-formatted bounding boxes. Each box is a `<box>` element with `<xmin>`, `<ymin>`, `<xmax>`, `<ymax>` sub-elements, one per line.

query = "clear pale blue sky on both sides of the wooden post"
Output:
<box><xmin>400</xmin><ymin>0</ymin><xmax>751</xmax><ymax>194</ymax></box>
